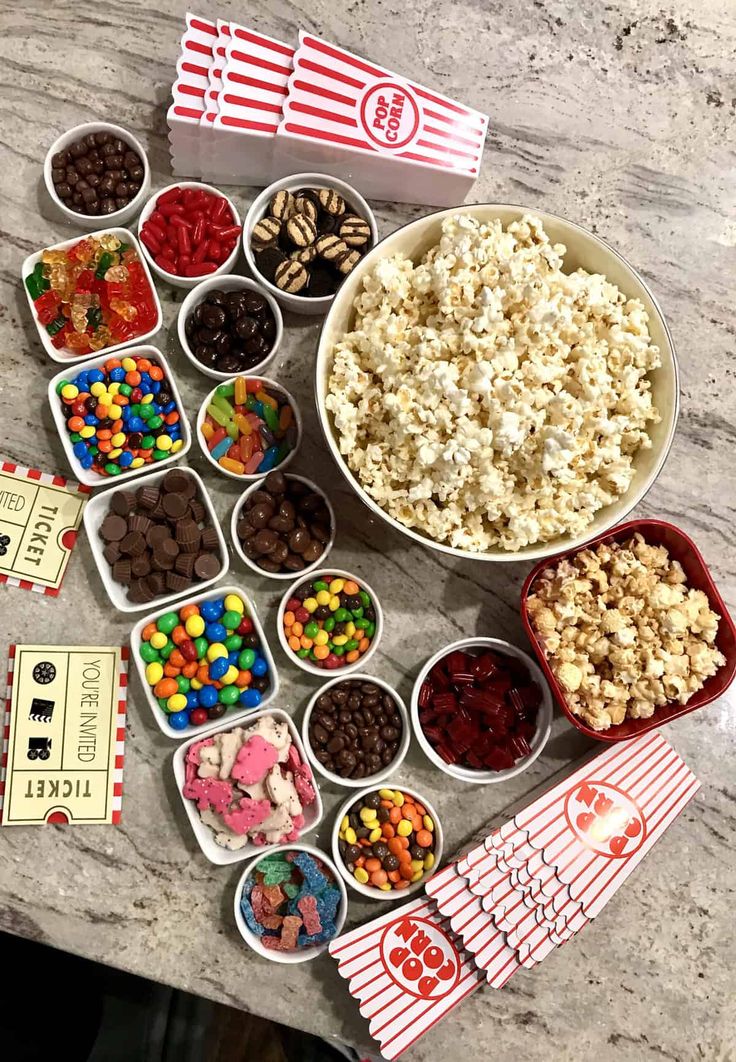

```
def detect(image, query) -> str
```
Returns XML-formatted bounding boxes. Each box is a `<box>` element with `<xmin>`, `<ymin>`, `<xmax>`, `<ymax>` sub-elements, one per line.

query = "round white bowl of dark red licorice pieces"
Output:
<box><xmin>411</xmin><ymin>638</ymin><xmax>552</xmax><ymax>785</ymax></box>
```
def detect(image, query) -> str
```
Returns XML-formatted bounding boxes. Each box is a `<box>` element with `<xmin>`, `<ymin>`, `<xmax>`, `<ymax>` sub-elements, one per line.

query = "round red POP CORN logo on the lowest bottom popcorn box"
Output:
<box><xmin>380</xmin><ymin>917</ymin><xmax>461</xmax><ymax>999</ymax></box>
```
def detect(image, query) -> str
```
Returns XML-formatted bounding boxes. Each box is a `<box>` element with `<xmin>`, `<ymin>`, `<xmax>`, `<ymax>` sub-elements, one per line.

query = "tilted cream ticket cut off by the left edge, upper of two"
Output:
<box><xmin>0</xmin><ymin>461</ymin><xmax>89</xmax><ymax>597</ymax></box>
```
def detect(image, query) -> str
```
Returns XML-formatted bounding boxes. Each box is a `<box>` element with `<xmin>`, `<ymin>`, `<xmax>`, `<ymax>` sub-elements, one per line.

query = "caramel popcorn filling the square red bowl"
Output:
<box><xmin>527</xmin><ymin>534</ymin><xmax>725</xmax><ymax>731</ymax></box>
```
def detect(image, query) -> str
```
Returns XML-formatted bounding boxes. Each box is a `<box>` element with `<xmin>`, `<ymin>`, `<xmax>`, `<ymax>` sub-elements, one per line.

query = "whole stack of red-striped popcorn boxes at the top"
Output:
<box><xmin>168</xmin><ymin>14</ymin><xmax>487</xmax><ymax>206</ymax></box>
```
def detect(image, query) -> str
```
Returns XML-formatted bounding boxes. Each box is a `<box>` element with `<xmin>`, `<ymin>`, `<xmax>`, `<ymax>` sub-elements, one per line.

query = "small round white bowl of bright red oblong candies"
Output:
<box><xmin>138</xmin><ymin>181</ymin><xmax>242</xmax><ymax>288</ymax></box>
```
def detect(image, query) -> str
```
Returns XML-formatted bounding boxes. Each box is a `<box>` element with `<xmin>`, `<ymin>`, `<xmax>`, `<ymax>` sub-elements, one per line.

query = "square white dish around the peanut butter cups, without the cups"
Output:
<box><xmin>84</xmin><ymin>465</ymin><xmax>228</xmax><ymax>612</ymax></box>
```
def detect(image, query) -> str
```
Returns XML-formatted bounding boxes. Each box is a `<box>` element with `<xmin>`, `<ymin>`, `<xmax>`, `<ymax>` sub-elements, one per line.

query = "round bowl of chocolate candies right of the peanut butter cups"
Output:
<box><xmin>230</xmin><ymin>469</ymin><xmax>336</xmax><ymax>579</ymax></box>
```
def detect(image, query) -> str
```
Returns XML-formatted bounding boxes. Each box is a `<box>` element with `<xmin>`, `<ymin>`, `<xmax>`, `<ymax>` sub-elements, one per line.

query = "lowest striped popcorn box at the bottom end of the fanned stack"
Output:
<box><xmin>329</xmin><ymin>896</ymin><xmax>484</xmax><ymax>1060</ymax></box>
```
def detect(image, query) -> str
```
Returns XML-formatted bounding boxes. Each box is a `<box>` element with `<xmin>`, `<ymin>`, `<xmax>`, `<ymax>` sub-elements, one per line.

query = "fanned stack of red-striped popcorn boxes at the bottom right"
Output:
<box><xmin>329</xmin><ymin>732</ymin><xmax>700</xmax><ymax>1060</ymax></box>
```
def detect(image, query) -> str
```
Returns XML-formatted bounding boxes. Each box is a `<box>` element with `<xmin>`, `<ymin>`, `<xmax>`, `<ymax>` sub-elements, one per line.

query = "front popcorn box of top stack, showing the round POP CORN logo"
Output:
<box><xmin>277</xmin><ymin>32</ymin><xmax>487</xmax><ymax>206</ymax></box>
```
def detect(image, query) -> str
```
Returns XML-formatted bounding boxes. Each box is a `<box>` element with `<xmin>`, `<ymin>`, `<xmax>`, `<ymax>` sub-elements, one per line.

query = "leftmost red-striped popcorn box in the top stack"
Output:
<box><xmin>167</xmin><ymin>12</ymin><xmax>218</xmax><ymax>177</ymax></box>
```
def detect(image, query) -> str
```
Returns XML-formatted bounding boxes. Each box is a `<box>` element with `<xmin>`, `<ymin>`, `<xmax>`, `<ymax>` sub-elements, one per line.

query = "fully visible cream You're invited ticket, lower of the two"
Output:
<box><xmin>0</xmin><ymin>645</ymin><xmax>129</xmax><ymax>826</ymax></box>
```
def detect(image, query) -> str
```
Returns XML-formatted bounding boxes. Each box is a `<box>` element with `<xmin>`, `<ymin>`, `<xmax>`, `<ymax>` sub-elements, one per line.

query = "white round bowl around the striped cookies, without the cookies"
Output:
<box><xmin>242</xmin><ymin>173</ymin><xmax>378</xmax><ymax>314</ymax></box>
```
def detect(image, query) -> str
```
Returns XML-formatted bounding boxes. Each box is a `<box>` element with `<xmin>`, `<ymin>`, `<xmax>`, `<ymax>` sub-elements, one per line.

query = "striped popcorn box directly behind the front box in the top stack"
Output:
<box><xmin>213</xmin><ymin>22</ymin><xmax>294</xmax><ymax>184</ymax></box>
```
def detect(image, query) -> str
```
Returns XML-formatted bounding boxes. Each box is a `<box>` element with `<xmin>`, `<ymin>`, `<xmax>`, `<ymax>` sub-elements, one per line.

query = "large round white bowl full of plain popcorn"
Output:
<box><xmin>315</xmin><ymin>204</ymin><xmax>679</xmax><ymax>561</ymax></box>
